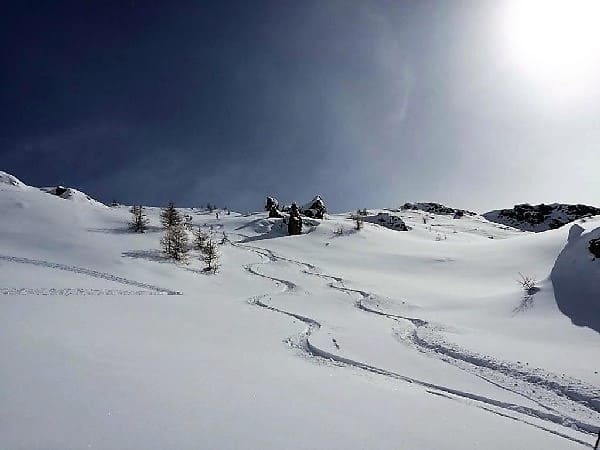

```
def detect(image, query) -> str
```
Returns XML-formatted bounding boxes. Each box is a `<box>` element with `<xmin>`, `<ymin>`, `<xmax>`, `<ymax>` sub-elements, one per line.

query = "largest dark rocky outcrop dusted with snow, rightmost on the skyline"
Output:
<box><xmin>483</xmin><ymin>203</ymin><xmax>600</xmax><ymax>232</ymax></box>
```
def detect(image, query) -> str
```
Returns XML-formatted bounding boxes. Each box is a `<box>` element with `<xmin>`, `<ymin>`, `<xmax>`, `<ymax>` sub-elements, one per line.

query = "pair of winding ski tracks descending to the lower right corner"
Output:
<box><xmin>231</xmin><ymin>235</ymin><xmax>600</xmax><ymax>447</ymax></box>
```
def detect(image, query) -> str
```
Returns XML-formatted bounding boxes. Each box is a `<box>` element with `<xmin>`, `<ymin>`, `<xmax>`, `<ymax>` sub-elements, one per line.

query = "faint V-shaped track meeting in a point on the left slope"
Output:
<box><xmin>0</xmin><ymin>255</ymin><xmax>181</xmax><ymax>295</ymax></box>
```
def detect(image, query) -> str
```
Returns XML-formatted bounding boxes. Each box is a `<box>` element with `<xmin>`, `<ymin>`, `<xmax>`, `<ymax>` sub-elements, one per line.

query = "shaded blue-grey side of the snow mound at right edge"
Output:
<box><xmin>550</xmin><ymin>225</ymin><xmax>600</xmax><ymax>333</ymax></box>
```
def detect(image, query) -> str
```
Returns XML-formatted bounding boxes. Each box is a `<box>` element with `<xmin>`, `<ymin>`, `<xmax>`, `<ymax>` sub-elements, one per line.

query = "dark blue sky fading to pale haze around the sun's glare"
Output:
<box><xmin>0</xmin><ymin>0</ymin><xmax>600</xmax><ymax>210</ymax></box>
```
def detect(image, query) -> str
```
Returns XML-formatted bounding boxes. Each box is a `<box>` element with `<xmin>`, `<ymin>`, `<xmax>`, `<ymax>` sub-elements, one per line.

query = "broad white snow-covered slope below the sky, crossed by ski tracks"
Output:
<box><xmin>0</xmin><ymin>173</ymin><xmax>600</xmax><ymax>450</ymax></box>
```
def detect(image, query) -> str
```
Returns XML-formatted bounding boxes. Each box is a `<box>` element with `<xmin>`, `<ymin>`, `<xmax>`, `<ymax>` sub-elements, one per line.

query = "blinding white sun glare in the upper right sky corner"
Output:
<box><xmin>502</xmin><ymin>0</ymin><xmax>600</xmax><ymax>97</ymax></box>
